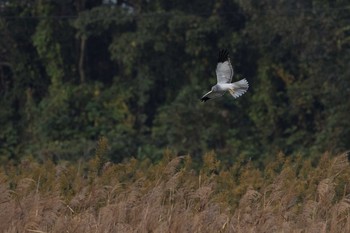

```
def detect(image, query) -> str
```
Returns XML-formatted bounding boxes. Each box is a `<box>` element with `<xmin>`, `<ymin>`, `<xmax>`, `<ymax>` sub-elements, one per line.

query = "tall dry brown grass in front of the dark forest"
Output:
<box><xmin>0</xmin><ymin>150</ymin><xmax>350</xmax><ymax>233</ymax></box>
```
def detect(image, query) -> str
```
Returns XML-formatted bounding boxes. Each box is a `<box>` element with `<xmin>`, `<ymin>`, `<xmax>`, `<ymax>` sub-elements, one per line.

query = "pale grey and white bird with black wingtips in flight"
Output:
<box><xmin>201</xmin><ymin>49</ymin><xmax>249</xmax><ymax>102</ymax></box>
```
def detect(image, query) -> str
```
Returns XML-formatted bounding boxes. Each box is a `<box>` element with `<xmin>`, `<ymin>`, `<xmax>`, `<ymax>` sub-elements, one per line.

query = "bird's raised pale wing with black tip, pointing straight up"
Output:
<box><xmin>216</xmin><ymin>49</ymin><xmax>233</xmax><ymax>83</ymax></box>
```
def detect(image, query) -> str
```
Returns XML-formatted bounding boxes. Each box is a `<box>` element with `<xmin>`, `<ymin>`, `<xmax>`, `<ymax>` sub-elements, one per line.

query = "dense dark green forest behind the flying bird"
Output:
<box><xmin>0</xmin><ymin>0</ymin><xmax>350</xmax><ymax>163</ymax></box>
